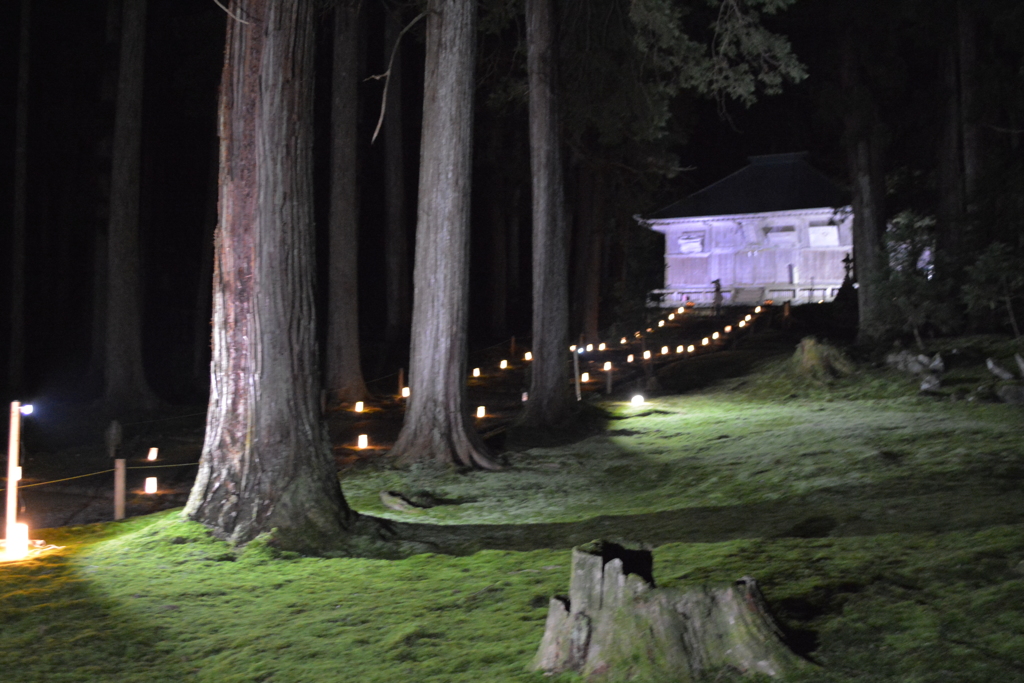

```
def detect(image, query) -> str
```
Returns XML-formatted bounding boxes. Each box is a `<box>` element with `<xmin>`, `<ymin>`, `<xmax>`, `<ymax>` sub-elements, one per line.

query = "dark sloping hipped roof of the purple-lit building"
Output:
<box><xmin>649</xmin><ymin>153</ymin><xmax>849</xmax><ymax>218</ymax></box>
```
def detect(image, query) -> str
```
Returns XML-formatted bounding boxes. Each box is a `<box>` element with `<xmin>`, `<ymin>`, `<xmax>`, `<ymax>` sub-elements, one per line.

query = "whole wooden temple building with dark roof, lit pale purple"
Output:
<box><xmin>638</xmin><ymin>154</ymin><xmax>853</xmax><ymax>308</ymax></box>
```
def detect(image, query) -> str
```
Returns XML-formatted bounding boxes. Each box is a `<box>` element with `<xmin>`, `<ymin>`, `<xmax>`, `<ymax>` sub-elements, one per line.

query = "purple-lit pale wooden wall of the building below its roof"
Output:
<box><xmin>649</xmin><ymin>208</ymin><xmax>853</xmax><ymax>305</ymax></box>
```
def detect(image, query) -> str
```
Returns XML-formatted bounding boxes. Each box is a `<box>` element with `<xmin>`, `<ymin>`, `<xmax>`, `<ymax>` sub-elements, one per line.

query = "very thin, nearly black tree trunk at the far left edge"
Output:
<box><xmin>7</xmin><ymin>0</ymin><xmax>32</xmax><ymax>396</ymax></box>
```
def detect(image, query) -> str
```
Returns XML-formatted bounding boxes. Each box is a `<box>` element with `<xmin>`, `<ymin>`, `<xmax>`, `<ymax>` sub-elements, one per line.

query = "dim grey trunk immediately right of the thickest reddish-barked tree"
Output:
<box><xmin>326</xmin><ymin>0</ymin><xmax>367</xmax><ymax>402</ymax></box>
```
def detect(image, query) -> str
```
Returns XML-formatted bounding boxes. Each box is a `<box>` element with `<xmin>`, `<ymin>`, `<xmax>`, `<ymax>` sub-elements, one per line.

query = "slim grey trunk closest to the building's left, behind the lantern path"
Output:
<box><xmin>522</xmin><ymin>0</ymin><xmax>572</xmax><ymax>427</ymax></box>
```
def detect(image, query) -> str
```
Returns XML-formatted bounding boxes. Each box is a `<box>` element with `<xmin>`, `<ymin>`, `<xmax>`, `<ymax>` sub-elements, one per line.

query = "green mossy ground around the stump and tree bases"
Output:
<box><xmin>0</xmin><ymin>339</ymin><xmax>1024</xmax><ymax>683</ymax></box>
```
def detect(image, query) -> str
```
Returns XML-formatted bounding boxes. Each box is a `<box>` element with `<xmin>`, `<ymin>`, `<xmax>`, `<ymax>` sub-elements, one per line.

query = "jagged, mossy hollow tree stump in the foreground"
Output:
<box><xmin>534</xmin><ymin>542</ymin><xmax>812</xmax><ymax>682</ymax></box>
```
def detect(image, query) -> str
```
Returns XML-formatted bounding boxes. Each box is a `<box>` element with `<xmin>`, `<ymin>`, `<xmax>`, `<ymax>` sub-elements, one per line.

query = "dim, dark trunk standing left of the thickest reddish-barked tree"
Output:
<box><xmin>103</xmin><ymin>0</ymin><xmax>157</xmax><ymax>411</ymax></box>
